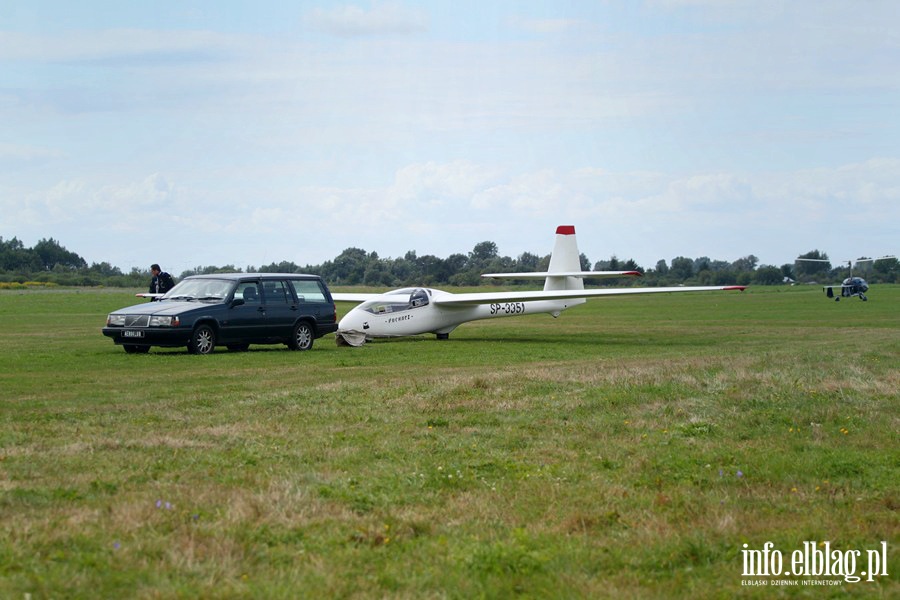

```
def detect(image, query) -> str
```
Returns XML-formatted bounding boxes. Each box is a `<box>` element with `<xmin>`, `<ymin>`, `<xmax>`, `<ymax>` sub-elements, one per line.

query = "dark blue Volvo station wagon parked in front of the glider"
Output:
<box><xmin>103</xmin><ymin>273</ymin><xmax>337</xmax><ymax>354</ymax></box>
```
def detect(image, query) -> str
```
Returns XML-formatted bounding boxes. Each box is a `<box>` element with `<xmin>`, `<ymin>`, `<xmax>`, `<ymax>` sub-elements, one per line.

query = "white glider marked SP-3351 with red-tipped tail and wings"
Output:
<box><xmin>332</xmin><ymin>225</ymin><xmax>745</xmax><ymax>346</ymax></box>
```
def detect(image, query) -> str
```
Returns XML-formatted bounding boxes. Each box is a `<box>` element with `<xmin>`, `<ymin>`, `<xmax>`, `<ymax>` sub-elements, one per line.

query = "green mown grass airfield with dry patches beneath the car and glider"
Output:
<box><xmin>0</xmin><ymin>286</ymin><xmax>900</xmax><ymax>598</ymax></box>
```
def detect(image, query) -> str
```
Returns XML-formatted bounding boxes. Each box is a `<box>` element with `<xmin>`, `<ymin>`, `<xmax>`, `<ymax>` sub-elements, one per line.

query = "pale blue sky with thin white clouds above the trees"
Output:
<box><xmin>0</xmin><ymin>0</ymin><xmax>900</xmax><ymax>275</ymax></box>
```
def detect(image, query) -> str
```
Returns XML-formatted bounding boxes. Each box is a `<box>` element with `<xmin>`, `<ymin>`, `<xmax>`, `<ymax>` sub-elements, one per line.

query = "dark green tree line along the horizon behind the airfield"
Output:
<box><xmin>0</xmin><ymin>237</ymin><xmax>900</xmax><ymax>287</ymax></box>
